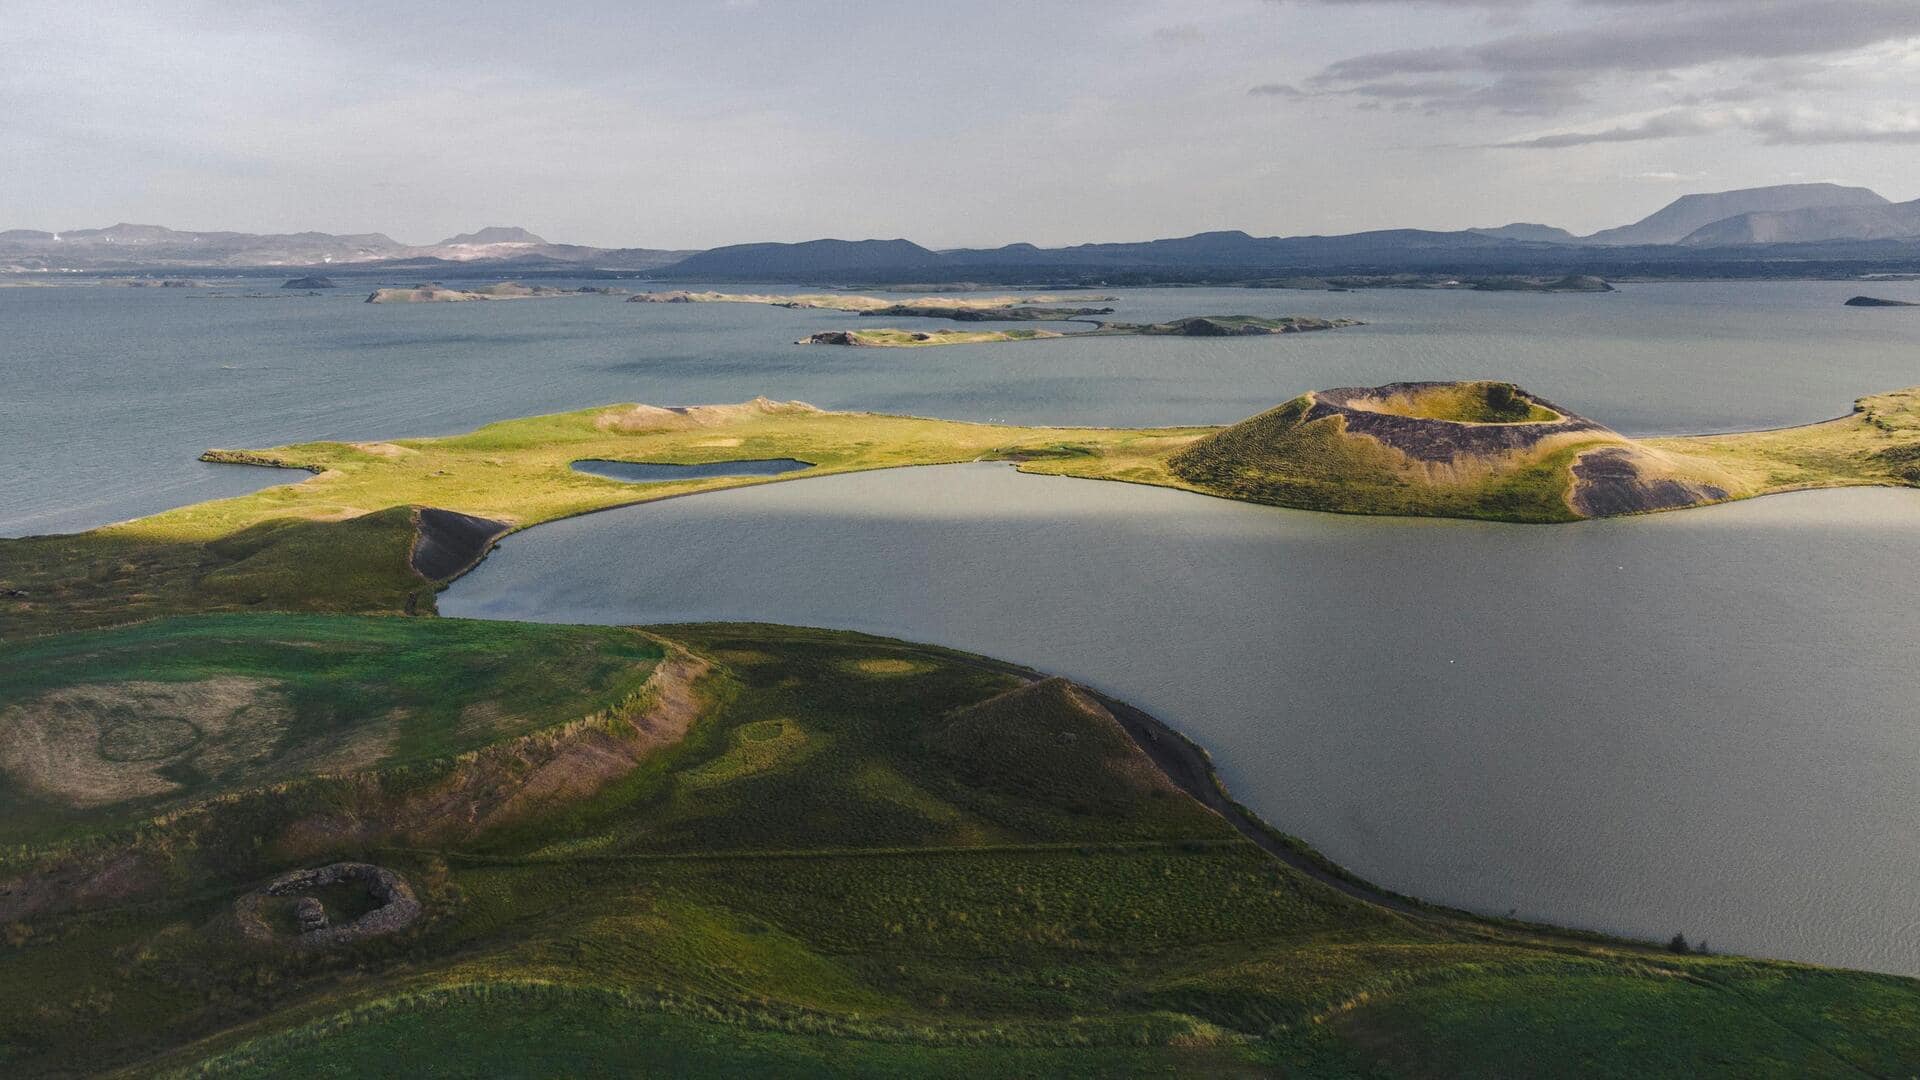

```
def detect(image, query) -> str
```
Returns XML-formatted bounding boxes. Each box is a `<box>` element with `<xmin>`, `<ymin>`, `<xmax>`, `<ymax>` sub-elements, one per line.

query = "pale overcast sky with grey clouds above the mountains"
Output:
<box><xmin>0</xmin><ymin>0</ymin><xmax>1920</xmax><ymax>248</ymax></box>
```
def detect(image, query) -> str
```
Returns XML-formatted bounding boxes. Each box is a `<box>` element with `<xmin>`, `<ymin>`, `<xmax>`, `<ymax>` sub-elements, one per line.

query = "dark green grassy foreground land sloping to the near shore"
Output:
<box><xmin>0</xmin><ymin>615</ymin><xmax>1920</xmax><ymax>1076</ymax></box>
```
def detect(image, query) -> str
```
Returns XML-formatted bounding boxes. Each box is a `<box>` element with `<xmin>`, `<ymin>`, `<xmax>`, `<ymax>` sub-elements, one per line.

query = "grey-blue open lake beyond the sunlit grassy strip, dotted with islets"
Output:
<box><xmin>0</xmin><ymin>272</ymin><xmax>1920</xmax><ymax>536</ymax></box>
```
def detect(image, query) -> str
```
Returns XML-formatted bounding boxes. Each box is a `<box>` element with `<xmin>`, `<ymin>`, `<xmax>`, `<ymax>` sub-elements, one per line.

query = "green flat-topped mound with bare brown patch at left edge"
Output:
<box><xmin>0</xmin><ymin>615</ymin><xmax>662</xmax><ymax>844</ymax></box>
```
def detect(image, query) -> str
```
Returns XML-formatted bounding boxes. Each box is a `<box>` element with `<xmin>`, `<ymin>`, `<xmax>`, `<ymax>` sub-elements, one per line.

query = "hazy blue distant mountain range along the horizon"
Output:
<box><xmin>11</xmin><ymin>184</ymin><xmax>1920</xmax><ymax>284</ymax></box>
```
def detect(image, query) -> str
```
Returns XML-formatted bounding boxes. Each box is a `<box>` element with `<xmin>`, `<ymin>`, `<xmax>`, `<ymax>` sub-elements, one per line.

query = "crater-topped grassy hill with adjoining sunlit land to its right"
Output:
<box><xmin>1167</xmin><ymin>382</ymin><xmax>1920</xmax><ymax>521</ymax></box>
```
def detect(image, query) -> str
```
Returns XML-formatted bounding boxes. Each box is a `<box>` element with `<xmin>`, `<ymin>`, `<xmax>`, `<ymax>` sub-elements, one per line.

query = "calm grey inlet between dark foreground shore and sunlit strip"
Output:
<box><xmin>442</xmin><ymin>465</ymin><xmax>1920</xmax><ymax>974</ymax></box>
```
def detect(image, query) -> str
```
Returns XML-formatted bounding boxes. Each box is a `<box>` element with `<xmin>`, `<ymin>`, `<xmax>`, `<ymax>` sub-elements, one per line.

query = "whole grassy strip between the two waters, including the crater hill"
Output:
<box><xmin>0</xmin><ymin>382</ymin><xmax>1920</xmax><ymax>640</ymax></box>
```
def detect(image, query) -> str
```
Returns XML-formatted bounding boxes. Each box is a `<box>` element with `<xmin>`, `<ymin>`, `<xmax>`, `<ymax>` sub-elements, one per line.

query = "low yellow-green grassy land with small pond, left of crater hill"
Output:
<box><xmin>0</xmin><ymin>400</ymin><xmax>1200</xmax><ymax>638</ymax></box>
